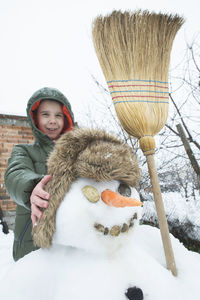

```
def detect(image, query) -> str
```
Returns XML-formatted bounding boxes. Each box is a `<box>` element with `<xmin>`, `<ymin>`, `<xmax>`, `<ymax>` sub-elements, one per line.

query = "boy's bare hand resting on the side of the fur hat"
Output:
<box><xmin>30</xmin><ymin>175</ymin><xmax>52</xmax><ymax>226</ymax></box>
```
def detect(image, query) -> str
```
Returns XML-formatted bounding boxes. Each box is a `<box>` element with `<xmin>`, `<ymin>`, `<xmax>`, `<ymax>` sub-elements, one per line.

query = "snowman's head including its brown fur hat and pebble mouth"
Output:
<box><xmin>33</xmin><ymin>128</ymin><xmax>141</xmax><ymax>249</ymax></box>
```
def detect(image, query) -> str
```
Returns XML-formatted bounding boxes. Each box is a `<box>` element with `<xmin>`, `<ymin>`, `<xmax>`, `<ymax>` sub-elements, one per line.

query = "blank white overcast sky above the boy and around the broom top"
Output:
<box><xmin>0</xmin><ymin>0</ymin><xmax>200</xmax><ymax>115</ymax></box>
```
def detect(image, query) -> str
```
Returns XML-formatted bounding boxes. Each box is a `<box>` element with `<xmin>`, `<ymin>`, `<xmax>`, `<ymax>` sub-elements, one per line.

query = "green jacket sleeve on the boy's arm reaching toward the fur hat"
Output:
<box><xmin>4</xmin><ymin>145</ymin><xmax>44</xmax><ymax>210</ymax></box>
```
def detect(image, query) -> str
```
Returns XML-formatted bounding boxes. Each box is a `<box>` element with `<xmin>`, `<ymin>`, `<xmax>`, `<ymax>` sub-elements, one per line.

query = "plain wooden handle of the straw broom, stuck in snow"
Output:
<box><xmin>146</xmin><ymin>154</ymin><xmax>177</xmax><ymax>276</ymax></box>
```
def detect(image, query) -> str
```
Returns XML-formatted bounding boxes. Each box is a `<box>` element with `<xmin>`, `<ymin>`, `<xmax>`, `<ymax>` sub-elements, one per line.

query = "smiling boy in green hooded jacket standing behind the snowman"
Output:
<box><xmin>4</xmin><ymin>87</ymin><xmax>74</xmax><ymax>260</ymax></box>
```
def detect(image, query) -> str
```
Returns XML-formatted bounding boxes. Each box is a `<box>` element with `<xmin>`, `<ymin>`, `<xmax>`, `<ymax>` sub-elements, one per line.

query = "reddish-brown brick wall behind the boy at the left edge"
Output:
<box><xmin>0</xmin><ymin>114</ymin><xmax>34</xmax><ymax>215</ymax></box>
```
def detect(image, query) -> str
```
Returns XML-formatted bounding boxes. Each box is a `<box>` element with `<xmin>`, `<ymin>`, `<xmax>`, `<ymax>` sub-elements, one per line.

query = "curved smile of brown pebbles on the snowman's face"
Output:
<box><xmin>94</xmin><ymin>213</ymin><xmax>137</xmax><ymax>236</ymax></box>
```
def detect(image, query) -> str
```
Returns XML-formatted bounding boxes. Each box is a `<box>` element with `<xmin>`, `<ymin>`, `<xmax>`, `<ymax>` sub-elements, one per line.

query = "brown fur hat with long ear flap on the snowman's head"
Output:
<box><xmin>33</xmin><ymin>128</ymin><xmax>140</xmax><ymax>248</ymax></box>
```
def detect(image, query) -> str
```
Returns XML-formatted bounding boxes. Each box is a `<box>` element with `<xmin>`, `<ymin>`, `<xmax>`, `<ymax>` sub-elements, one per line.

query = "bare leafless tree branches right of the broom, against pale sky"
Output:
<box><xmin>160</xmin><ymin>34</ymin><xmax>200</xmax><ymax>190</ymax></box>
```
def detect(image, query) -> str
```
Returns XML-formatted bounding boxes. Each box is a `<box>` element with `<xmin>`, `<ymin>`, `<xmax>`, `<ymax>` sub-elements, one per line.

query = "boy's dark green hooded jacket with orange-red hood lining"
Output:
<box><xmin>4</xmin><ymin>87</ymin><xmax>74</xmax><ymax>260</ymax></box>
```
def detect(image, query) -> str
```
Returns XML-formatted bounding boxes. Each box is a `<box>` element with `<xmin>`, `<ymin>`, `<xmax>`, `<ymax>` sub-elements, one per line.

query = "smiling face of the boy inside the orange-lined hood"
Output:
<box><xmin>37</xmin><ymin>100</ymin><xmax>64</xmax><ymax>140</ymax></box>
